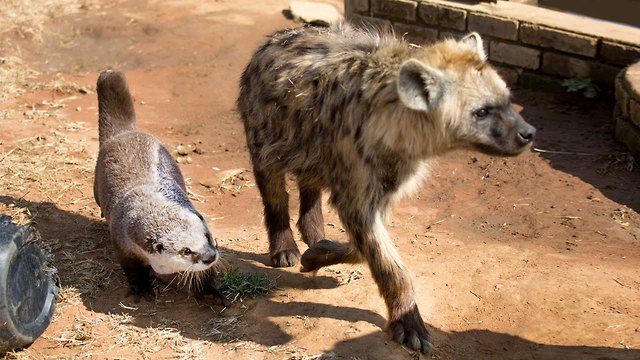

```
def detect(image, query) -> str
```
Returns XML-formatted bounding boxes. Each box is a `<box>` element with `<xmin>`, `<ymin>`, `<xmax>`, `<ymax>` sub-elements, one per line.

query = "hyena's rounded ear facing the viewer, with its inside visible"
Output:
<box><xmin>397</xmin><ymin>59</ymin><xmax>444</xmax><ymax>111</ymax></box>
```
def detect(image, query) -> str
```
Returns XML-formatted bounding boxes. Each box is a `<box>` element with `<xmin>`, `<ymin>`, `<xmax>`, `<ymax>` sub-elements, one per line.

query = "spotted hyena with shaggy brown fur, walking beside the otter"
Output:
<box><xmin>238</xmin><ymin>24</ymin><xmax>535</xmax><ymax>352</ymax></box>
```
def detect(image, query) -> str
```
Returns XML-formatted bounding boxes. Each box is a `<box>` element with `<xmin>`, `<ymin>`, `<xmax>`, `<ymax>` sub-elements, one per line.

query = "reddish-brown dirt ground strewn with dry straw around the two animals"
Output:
<box><xmin>0</xmin><ymin>0</ymin><xmax>640</xmax><ymax>360</ymax></box>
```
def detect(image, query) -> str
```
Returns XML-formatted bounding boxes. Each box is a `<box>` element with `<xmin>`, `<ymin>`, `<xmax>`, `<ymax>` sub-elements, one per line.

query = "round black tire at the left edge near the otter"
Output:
<box><xmin>0</xmin><ymin>216</ymin><xmax>60</xmax><ymax>353</ymax></box>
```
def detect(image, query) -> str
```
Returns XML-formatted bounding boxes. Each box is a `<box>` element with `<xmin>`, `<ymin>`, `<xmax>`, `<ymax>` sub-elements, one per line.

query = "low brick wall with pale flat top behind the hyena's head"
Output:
<box><xmin>345</xmin><ymin>0</ymin><xmax>640</xmax><ymax>90</ymax></box>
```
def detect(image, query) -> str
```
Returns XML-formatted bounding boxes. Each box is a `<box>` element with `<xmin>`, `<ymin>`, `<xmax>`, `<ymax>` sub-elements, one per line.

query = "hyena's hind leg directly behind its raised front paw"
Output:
<box><xmin>298</xmin><ymin>179</ymin><xmax>325</xmax><ymax>247</ymax></box>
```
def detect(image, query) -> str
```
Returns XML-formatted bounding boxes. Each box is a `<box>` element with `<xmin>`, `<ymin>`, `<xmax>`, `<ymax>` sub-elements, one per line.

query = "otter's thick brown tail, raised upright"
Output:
<box><xmin>97</xmin><ymin>70</ymin><xmax>136</xmax><ymax>144</ymax></box>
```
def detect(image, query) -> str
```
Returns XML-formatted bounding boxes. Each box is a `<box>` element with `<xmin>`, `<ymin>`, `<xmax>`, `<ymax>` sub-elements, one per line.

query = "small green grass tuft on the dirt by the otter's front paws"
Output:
<box><xmin>219</xmin><ymin>268</ymin><xmax>275</xmax><ymax>302</ymax></box>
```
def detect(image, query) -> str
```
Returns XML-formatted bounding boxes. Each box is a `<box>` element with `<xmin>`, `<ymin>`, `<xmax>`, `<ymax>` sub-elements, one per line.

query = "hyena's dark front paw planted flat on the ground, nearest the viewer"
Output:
<box><xmin>389</xmin><ymin>307</ymin><xmax>433</xmax><ymax>354</ymax></box>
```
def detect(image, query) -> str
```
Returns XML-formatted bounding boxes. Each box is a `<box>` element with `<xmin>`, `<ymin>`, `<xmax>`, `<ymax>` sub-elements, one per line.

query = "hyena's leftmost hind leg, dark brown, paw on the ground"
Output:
<box><xmin>254</xmin><ymin>167</ymin><xmax>300</xmax><ymax>267</ymax></box>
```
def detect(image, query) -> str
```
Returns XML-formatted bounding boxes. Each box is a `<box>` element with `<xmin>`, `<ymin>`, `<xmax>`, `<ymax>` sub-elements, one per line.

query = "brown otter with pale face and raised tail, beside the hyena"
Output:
<box><xmin>93</xmin><ymin>70</ymin><xmax>228</xmax><ymax>305</ymax></box>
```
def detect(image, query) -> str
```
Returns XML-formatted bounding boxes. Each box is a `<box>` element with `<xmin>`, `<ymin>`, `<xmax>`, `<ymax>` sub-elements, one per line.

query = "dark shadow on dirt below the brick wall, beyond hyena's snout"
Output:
<box><xmin>514</xmin><ymin>90</ymin><xmax>640</xmax><ymax>212</ymax></box>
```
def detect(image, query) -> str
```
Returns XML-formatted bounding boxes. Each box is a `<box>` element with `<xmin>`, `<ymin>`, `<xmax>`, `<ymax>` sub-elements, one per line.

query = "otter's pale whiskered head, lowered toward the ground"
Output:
<box><xmin>134</xmin><ymin>206</ymin><xmax>220</xmax><ymax>274</ymax></box>
